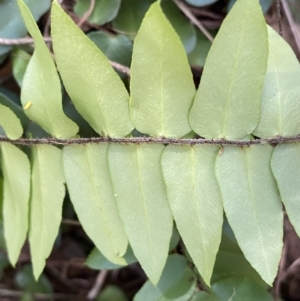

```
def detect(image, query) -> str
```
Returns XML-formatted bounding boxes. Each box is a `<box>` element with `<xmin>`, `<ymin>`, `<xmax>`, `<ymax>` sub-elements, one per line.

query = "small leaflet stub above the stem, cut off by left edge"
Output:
<box><xmin>0</xmin><ymin>104</ymin><xmax>23</xmax><ymax>140</ymax></box>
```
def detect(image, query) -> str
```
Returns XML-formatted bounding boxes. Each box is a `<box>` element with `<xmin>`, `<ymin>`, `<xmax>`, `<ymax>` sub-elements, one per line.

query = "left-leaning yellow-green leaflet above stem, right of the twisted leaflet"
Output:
<box><xmin>51</xmin><ymin>1</ymin><xmax>133</xmax><ymax>137</ymax></box>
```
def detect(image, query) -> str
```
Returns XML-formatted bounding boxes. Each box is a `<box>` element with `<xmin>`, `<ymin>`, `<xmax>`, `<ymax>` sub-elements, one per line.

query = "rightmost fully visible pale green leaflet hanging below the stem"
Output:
<box><xmin>216</xmin><ymin>145</ymin><xmax>283</xmax><ymax>285</ymax></box>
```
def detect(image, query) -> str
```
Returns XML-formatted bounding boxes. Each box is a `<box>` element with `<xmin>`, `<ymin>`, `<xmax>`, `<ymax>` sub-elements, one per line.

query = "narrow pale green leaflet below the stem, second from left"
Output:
<box><xmin>29</xmin><ymin>145</ymin><xmax>65</xmax><ymax>279</ymax></box>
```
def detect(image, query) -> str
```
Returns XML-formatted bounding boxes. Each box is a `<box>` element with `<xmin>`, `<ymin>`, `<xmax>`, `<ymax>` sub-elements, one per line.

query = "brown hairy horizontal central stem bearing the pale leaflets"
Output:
<box><xmin>0</xmin><ymin>135</ymin><xmax>300</xmax><ymax>146</ymax></box>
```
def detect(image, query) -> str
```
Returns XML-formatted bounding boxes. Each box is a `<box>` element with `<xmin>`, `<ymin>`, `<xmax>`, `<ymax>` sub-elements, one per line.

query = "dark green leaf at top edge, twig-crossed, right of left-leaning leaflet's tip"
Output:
<box><xmin>74</xmin><ymin>0</ymin><xmax>121</xmax><ymax>25</ymax></box>
